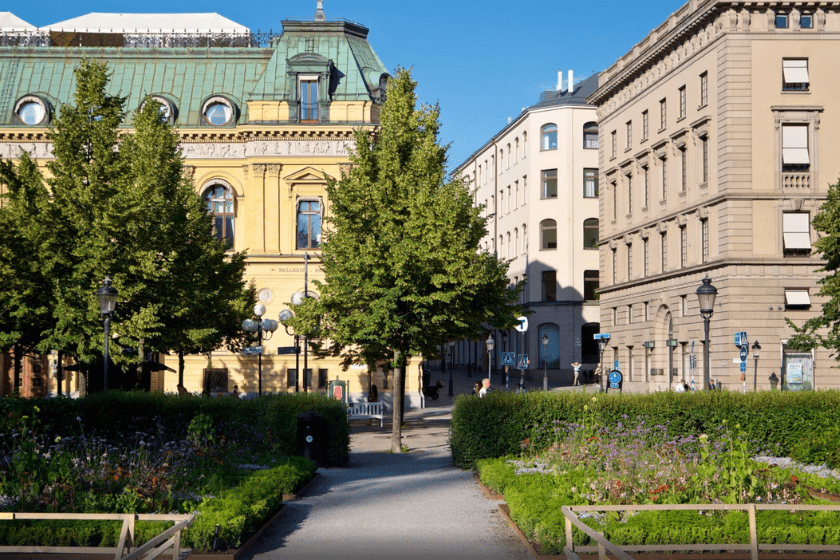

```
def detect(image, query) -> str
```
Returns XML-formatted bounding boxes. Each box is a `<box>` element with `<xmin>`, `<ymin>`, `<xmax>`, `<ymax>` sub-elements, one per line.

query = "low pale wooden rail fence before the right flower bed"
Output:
<box><xmin>560</xmin><ymin>504</ymin><xmax>840</xmax><ymax>560</ymax></box>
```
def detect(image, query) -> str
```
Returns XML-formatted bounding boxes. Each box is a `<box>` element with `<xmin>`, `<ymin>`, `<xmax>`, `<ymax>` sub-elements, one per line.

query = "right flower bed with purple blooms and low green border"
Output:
<box><xmin>477</xmin><ymin>398</ymin><xmax>840</xmax><ymax>554</ymax></box>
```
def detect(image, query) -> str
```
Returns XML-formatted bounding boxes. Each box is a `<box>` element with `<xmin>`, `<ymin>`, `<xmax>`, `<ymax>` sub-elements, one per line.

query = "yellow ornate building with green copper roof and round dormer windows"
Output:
<box><xmin>0</xmin><ymin>8</ymin><xmax>422</xmax><ymax>407</ymax></box>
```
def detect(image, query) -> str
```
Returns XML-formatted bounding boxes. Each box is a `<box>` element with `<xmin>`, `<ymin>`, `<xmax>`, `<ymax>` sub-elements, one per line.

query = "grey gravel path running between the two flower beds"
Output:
<box><xmin>241</xmin><ymin>404</ymin><xmax>529</xmax><ymax>560</ymax></box>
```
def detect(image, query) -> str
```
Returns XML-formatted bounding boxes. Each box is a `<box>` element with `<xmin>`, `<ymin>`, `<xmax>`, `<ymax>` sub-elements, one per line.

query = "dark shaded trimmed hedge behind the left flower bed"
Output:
<box><xmin>0</xmin><ymin>391</ymin><xmax>350</xmax><ymax>465</ymax></box>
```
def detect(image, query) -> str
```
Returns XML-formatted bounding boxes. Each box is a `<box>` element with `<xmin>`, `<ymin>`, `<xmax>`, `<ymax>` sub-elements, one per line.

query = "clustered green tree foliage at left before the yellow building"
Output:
<box><xmin>0</xmin><ymin>60</ymin><xmax>254</xmax><ymax>390</ymax></box>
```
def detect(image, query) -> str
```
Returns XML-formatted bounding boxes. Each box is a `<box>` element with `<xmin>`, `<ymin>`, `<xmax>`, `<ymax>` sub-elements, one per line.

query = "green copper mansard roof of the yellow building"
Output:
<box><xmin>0</xmin><ymin>21</ymin><xmax>387</xmax><ymax>127</ymax></box>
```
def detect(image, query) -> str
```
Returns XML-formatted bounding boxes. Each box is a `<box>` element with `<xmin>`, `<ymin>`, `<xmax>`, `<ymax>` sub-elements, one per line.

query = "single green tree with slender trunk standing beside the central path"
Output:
<box><xmin>296</xmin><ymin>70</ymin><xmax>518</xmax><ymax>453</ymax></box>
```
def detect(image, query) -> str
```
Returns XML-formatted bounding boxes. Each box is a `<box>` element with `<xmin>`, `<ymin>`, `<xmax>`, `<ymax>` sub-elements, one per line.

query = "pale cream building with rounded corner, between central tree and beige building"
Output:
<box><xmin>454</xmin><ymin>72</ymin><xmax>599</xmax><ymax>384</ymax></box>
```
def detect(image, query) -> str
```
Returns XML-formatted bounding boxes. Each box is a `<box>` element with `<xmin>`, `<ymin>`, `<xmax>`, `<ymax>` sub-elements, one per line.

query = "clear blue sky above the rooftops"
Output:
<box><xmin>16</xmin><ymin>0</ymin><xmax>687</xmax><ymax>169</ymax></box>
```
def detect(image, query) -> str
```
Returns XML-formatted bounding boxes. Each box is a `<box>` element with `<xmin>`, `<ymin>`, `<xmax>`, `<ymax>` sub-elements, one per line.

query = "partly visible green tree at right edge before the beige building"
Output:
<box><xmin>788</xmin><ymin>182</ymin><xmax>840</xmax><ymax>360</ymax></box>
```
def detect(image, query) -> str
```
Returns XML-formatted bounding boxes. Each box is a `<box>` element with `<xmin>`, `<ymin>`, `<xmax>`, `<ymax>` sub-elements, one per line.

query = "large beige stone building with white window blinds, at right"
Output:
<box><xmin>589</xmin><ymin>0</ymin><xmax>840</xmax><ymax>391</ymax></box>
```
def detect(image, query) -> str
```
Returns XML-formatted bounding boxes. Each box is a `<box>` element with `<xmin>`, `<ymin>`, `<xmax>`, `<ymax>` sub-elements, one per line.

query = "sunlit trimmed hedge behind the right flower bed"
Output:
<box><xmin>451</xmin><ymin>390</ymin><xmax>840</xmax><ymax>469</ymax></box>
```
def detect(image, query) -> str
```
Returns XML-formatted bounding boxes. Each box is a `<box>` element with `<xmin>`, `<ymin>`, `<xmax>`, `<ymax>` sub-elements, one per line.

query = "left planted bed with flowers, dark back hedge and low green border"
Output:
<box><xmin>0</xmin><ymin>393</ymin><xmax>342</xmax><ymax>550</ymax></box>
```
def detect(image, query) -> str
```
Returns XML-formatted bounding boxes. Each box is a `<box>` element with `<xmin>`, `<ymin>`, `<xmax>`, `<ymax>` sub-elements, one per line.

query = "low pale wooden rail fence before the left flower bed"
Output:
<box><xmin>0</xmin><ymin>513</ymin><xmax>195</xmax><ymax>560</ymax></box>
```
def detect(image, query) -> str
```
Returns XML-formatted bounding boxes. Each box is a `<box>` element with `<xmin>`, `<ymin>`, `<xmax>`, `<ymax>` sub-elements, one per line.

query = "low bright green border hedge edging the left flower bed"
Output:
<box><xmin>0</xmin><ymin>457</ymin><xmax>316</xmax><ymax>551</ymax></box>
